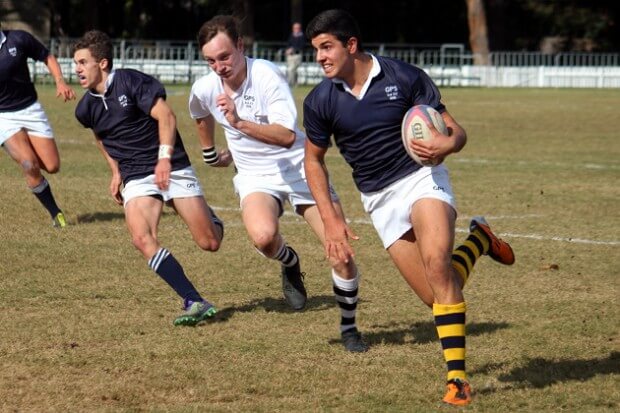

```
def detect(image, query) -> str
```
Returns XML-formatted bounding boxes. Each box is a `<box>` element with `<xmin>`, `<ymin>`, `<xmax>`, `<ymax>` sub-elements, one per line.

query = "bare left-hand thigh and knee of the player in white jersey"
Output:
<box><xmin>241</xmin><ymin>192</ymin><xmax>281</xmax><ymax>241</ymax></box>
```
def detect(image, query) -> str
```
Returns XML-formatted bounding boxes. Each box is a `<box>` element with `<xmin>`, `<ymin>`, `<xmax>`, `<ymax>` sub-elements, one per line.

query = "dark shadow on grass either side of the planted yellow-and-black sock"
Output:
<box><xmin>363</xmin><ymin>321</ymin><xmax>509</xmax><ymax>345</ymax></box>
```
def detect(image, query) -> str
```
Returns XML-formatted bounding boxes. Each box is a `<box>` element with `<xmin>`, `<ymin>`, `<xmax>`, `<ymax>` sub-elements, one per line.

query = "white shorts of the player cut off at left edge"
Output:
<box><xmin>0</xmin><ymin>102</ymin><xmax>54</xmax><ymax>145</ymax></box>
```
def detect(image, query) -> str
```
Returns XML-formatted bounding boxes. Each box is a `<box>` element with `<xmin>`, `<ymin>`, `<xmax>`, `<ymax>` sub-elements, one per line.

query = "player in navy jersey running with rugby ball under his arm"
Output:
<box><xmin>304</xmin><ymin>10</ymin><xmax>515</xmax><ymax>405</ymax></box>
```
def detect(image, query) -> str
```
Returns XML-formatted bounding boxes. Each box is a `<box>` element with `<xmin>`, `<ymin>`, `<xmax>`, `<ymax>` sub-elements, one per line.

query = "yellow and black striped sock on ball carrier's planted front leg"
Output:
<box><xmin>433</xmin><ymin>302</ymin><xmax>467</xmax><ymax>381</ymax></box>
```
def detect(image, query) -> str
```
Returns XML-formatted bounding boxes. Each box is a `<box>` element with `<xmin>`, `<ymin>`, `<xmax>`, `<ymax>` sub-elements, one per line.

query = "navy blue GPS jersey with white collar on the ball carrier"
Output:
<box><xmin>304</xmin><ymin>56</ymin><xmax>445</xmax><ymax>193</ymax></box>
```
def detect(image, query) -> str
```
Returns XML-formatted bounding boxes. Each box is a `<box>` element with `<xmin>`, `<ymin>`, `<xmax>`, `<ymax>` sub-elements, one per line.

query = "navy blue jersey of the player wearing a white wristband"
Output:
<box><xmin>75</xmin><ymin>69</ymin><xmax>190</xmax><ymax>184</ymax></box>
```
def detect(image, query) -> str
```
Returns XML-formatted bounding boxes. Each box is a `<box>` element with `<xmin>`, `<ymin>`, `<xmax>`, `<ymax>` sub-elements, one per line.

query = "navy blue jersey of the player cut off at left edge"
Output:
<box><xmin>0</xmin><ymin>30</ymin><xmax>49</xmax><ymax>112</ymax></box>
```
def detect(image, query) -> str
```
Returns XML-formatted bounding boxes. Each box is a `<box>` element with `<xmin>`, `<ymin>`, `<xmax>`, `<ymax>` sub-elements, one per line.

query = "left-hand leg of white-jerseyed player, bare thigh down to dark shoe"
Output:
<box><xmin>241</xmin><ymin>192</ymin><xmax>307</xmax><ymax>310</ymax></box>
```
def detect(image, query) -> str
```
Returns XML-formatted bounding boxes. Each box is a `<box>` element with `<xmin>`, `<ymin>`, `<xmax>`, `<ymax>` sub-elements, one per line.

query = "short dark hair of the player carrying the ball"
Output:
<box><xmin>306</xmin><ymin>9</ymin><xmax>364</xmax><ymax>51</ymax></box>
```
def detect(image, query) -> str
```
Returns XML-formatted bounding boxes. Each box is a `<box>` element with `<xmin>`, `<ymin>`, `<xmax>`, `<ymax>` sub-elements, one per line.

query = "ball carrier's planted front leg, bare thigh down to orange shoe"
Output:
<box><xmin>411</xmin><ymin>198</ymin><xmax>470</xmax><ymax>404</ymax></box>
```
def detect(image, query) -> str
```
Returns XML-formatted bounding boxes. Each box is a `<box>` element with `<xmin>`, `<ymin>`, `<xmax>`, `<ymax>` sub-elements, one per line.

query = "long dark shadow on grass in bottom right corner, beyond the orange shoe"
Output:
<box><xmin>482</xmin><ymin>351</ymin><xmax>620</xmax><ymax>392</ymax></box>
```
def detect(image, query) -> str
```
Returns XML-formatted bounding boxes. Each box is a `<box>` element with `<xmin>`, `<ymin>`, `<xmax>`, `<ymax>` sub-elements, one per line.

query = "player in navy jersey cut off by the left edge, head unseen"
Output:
<box><xmin>0</xmin><ymin>22</ymin><xmax>75</xmax><ymax>228</ymax></box>
